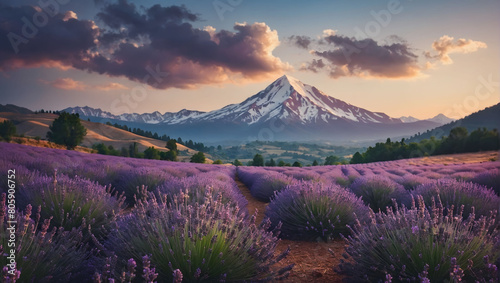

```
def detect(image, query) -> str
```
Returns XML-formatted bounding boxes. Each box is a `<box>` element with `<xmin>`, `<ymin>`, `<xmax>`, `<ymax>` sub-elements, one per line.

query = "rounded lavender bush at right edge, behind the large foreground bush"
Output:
<box><xmin>412</xmin><ymin>179</ymin><xmax>500</xmax><ymax>218</ymax></box>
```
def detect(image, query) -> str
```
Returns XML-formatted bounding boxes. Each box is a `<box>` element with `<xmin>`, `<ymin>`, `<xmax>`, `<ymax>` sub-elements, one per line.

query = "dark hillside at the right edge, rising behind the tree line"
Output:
<box><xmin>408</xmin><ymin>103</ymin><xmax>500</xmax><ymax>142</ymax></box>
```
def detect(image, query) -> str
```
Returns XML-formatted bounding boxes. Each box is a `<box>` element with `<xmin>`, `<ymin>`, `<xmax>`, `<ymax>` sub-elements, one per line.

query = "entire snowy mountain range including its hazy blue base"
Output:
<box><xmin>63</xmin><ymin>75</ymin><xmax>449</xmax><ymax>142</ymax></box>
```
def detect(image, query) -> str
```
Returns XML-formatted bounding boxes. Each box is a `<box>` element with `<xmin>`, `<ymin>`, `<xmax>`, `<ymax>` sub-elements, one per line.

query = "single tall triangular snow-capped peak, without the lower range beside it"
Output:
<box><xmin>186</xmin><ymin>75</ymin><xmax>401</xmax><ymax>125</ymax></box>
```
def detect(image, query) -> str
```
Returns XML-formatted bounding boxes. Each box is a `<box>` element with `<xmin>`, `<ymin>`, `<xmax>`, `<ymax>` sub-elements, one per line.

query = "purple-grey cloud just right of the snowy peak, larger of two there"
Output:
<box><xmin>301</xmin><ymin>34</ymin><xmax>421</xmax><ymax>79</ymax></box>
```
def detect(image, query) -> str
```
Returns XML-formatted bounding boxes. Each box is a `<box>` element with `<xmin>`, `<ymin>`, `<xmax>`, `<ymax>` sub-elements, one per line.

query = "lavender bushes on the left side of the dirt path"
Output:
<box><xmin>0</xmin><ymin>143</ymin><xmax>293</xmax><ymax>282</ymax></box>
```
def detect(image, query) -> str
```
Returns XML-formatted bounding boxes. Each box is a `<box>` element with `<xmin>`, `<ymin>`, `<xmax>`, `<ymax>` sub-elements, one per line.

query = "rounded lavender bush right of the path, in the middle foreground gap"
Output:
<box><xmin>265</xmin><ymin>182</ymin><xmax>368</xmax><ymax>241</ymax></box>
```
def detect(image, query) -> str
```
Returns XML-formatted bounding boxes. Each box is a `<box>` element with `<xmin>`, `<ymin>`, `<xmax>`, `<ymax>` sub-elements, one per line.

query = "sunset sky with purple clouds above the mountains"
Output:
<box><xmin>0</xmin><ymin>0</ymin><xmax>500</xmax><ymax>119</ymax></box>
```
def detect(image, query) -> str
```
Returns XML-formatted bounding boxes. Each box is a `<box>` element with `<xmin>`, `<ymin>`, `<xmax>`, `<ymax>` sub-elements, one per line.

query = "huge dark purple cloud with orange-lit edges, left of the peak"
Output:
<box><xmin>0</xmin><ymin>0</ymin><xmax>291</xmax><ymax>89</ymax></box>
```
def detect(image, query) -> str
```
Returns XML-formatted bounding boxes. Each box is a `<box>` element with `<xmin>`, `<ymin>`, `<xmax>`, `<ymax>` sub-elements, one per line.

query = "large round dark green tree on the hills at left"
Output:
<box><xmin>47</xmin><ymin>112</ymin><xmax>87</xmax><ymax>149</ymax></box>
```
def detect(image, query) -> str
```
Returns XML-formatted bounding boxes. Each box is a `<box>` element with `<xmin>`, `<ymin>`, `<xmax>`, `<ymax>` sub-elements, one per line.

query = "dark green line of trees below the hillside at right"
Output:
<box><xmin>350</xmin><ymin>127</ymin><xmax>500</xmax><ymax>164</ymax></box>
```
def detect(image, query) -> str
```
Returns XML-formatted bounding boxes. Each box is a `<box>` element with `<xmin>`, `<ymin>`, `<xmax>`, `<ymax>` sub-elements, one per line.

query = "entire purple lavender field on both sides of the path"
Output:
<box><xmin>0</xmin><ymin>143</ymin><xmax>500</xmax><ymax>282</ymax></box>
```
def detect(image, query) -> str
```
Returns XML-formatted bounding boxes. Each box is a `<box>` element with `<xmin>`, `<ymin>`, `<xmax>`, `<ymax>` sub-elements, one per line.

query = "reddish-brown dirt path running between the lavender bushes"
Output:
<box><xmin>235</xmin><ymin>177</ymin><xmax>345</xmax><ymax>282</ymax></box>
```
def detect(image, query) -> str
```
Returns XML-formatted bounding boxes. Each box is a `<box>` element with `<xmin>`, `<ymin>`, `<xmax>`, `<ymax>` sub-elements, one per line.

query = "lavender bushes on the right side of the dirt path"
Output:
<box><xmin>238</xmin><ymin>158</ymin><xmax>500</xmax><ymax>282</ymax></box>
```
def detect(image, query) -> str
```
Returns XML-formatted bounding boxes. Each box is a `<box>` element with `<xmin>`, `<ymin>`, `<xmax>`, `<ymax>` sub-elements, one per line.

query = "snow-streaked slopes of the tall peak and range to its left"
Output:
<box><xmin>65</xmin><ymin>75</ymin><xmax>402</xmax><ymax>125</ymax></box>
